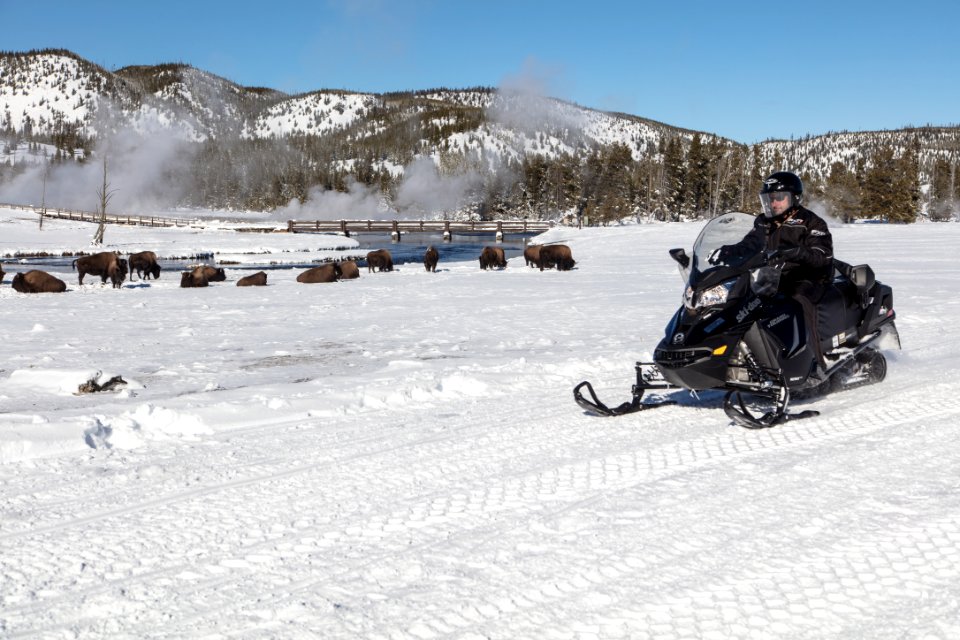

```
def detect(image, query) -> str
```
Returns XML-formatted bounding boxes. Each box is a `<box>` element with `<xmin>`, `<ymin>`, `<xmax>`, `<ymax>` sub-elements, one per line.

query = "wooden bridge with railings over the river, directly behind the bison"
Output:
<box><xmin>287</xmin><ymin>220</ymin><xmax>554</xmax><ymax>242</ymax></box>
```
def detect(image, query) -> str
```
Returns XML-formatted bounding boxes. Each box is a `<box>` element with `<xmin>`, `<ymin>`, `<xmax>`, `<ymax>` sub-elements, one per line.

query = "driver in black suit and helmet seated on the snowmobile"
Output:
<box><xmin>709</xmin><ymin>171</ymin><xmax>833</xmax><ymax>368</ymax></box>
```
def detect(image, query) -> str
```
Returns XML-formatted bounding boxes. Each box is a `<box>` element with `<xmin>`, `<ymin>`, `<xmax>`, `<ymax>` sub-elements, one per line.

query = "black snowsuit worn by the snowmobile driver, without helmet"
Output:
<box><xmin>737</xmin><ymin>207</ymin><xmax>833</xmax><ymax>367</ymax></box>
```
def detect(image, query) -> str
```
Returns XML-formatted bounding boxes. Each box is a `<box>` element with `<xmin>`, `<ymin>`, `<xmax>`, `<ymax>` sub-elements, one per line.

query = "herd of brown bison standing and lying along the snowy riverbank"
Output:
<box><xmin>0</xmin><ymin>244</ymin><xmax>576</xmax><ymax>293</ymax></box>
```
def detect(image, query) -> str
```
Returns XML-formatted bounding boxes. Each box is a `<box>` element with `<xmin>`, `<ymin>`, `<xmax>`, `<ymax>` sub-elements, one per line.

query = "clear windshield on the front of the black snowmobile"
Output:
<box><xmin>688</xmin><ymin>212</ymin><xmax>756</xmax><ymax>286</ymax></box>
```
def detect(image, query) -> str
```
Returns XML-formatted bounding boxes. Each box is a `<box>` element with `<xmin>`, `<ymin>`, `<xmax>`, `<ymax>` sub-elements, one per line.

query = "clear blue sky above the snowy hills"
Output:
<box><xmin>0</xmin><ymin>0</ymin><xmax>960</xmax><ymax>143</ymax></box>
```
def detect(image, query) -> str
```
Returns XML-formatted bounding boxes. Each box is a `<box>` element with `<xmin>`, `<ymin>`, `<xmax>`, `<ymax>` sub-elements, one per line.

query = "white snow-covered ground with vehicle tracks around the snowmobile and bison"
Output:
<box><xmin>0</xmin><ymin>209</ymin><xmax>960</xmax><ymax>639</ymax></box>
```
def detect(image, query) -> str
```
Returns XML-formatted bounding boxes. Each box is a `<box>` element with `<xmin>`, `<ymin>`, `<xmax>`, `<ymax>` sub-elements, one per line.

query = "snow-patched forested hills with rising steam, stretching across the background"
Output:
<box><xmin>0</xmin><ymin>50</ymin><xmax>960</xmax><ymax>223</ymax></box>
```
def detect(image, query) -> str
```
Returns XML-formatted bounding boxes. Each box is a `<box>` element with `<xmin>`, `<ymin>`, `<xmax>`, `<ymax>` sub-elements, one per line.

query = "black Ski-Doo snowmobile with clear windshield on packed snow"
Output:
<box><xmin>573</xmin><ymin>213</ymin><xmax>900</xmax><ymax>429</ymax></box>
